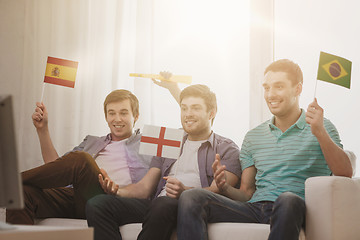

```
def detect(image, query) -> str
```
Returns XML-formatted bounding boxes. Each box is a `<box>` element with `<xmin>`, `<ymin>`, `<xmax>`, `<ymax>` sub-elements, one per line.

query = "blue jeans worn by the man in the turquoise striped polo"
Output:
<box><xmin>177</xmin><ymin>189</ymin><xmax>305</xmax><ymax>240</ymax></box>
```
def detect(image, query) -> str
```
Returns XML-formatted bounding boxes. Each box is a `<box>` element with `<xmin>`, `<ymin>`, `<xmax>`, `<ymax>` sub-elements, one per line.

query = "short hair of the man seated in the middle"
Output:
<box><xmin>180</xmin><ymin>84</ymin><xmax>217</xmax><ymax>124</ymax></box>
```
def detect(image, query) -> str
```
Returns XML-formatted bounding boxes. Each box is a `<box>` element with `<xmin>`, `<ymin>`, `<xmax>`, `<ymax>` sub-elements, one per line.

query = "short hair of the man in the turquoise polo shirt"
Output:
<box><xmin>264</xmin><ymin>59</ymin><xmax>303</xmax><ymax>85</ymax></box>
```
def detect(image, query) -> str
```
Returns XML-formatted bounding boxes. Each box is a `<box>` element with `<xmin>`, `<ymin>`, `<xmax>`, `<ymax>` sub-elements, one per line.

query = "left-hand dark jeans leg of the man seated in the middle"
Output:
<box><xmin>86</xmin><ymin>194</ymin><xmax>151</xmax><ymax>240</ymax></box>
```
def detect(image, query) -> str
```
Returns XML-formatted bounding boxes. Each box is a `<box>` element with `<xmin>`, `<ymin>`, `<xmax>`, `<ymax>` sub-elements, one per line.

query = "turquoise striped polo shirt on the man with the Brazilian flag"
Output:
<box><xmin>240</xmin><ymin>109</ymin><xmax>342</xmax><ymax>202</ymax></box>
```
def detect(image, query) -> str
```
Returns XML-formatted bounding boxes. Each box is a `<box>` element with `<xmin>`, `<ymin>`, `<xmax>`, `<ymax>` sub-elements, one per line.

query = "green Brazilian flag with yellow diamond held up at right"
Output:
<box><xmin>317</xmin><ymin>52</ymin><xmax>351</xmax><ymax>89</ymax></box>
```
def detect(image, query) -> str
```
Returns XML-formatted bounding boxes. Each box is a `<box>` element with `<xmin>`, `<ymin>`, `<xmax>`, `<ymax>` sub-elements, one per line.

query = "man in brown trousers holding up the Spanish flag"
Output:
<box><xmin>6</xmin><ymin>90</ymin><xmax>151</xmax><ymax>224</ymax></box>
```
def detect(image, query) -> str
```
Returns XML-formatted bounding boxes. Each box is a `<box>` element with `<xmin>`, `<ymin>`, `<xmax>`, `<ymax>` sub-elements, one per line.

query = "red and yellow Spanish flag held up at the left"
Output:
<box><xmin>44</xmin><ymin>57</ymin><xmax>78</xmax><ymax>88</ymax></box>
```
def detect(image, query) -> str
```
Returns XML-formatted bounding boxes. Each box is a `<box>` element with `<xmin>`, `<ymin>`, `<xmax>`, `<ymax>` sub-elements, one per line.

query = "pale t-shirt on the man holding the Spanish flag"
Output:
<box><xmin>95</xmin><ymin>139</ymin><xmax>132</xmax><ymax>187</ymax></box>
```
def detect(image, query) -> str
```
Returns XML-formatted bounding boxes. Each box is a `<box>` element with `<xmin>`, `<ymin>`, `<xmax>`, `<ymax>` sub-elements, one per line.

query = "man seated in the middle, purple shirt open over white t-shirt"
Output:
<box><xmin>86</xmin><ymin>85</ymin><xmax>240</xmax><ymax>240</ymax></box>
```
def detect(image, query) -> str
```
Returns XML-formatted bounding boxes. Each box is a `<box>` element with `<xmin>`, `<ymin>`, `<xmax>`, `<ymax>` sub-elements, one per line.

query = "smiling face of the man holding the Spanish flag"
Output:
<box><xmin>106</xmin><ymin>99</ymin><xmax>138</xmax><ymax>141</ymax></box>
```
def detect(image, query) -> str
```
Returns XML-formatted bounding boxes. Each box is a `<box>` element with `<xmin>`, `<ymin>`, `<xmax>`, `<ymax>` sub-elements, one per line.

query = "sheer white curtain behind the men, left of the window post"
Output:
<box><xmin>0</xmin><ymin>0</ymin><xmax>250</xmax><ymax>170</ymax></box>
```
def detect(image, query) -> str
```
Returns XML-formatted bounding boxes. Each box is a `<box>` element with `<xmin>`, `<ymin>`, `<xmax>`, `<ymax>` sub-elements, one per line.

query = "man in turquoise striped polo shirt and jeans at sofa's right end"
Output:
<box><xmin>177</xmin><ymin>59</ymin><xmax>352</xmax><ymax>240</ymax></box>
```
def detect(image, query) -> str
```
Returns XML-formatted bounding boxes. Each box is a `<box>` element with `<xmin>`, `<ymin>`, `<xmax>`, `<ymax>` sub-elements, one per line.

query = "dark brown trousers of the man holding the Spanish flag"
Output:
<box><xmin>6</xmin><ymin>152</ymin><xmax>104</xmax><ymax>224</ymax></box>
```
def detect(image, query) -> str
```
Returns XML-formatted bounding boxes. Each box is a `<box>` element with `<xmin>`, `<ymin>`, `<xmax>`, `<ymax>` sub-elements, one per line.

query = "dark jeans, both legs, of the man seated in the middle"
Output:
<box><xmin>86</xmin><ymin>194</ymin><xmax>178</xmax><ymax>240</ymax></box>
